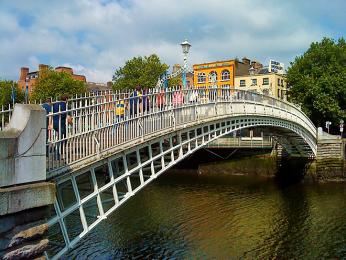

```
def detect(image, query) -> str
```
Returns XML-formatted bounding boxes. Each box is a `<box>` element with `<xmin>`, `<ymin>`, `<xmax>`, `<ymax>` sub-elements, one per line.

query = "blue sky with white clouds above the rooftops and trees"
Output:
<box><xmin>0</xmin><ymin>0</ymin><xmax>346</xmax><ymax>83</ymax></box>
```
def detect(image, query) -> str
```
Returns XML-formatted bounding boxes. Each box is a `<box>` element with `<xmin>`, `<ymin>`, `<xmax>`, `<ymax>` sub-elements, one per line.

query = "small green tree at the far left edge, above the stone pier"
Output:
<box><xmin>0</xmin><ymin>80</ymin><xmax>24</xmax><ymax>108</ymax></box>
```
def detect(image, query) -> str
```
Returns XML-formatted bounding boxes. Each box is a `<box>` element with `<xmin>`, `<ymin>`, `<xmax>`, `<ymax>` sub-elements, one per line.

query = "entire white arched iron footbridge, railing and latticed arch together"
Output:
<box><xmin>33</xmin><ymin>88</ymin><xmax>316</xmax><ymax>259</ymax></box>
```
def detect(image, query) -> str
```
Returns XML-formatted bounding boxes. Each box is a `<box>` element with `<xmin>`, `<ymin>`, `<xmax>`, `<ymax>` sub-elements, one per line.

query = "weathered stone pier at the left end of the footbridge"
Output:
<box><xmin>0</xmin><ymin>104</ymin><xmax>55</xmax><ymax>259</ymax></box>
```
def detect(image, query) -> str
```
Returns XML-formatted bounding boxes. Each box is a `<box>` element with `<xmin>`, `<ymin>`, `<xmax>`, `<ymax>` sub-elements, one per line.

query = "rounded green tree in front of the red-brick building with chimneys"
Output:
<box><xmin>30</xmin><ymin>68</ymin><xmax>86</xmax><ymax>101</ymax></box>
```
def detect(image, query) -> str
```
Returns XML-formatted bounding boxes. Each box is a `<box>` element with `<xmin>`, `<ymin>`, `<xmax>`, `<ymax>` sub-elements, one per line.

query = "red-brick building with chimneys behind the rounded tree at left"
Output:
<box><xmin>18</xmin><ymin>64</ymin><xmax>86</xmax><ymax>93</ymax></box>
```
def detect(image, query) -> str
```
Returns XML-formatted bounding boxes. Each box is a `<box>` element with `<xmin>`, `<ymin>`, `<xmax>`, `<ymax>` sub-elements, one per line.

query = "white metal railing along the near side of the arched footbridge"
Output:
<box><xmin>46</xmin><ymin>87</ymin><xmax>315</xmax><ymax>178</ymax></box>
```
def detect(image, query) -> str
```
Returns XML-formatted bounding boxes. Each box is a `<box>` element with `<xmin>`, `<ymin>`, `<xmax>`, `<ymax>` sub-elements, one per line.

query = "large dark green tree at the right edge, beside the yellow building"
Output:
<box><xmin>287</xmin><ymin>38</ymin><xmax>346</xmax><ymax>126</ymax></box>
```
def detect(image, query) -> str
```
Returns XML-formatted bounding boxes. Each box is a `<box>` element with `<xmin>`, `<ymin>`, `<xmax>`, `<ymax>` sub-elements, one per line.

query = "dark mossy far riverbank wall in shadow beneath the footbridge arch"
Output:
<box><xmin>170</xmin><ymin>149</ymin><xmax>346</xmax><ymax>183</ymax></box>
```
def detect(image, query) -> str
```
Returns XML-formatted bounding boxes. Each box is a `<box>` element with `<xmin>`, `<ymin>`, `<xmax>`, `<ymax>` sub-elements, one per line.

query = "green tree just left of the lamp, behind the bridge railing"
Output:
<box><xmin>113</xmin><ymin>54</ymin><xmax>168</xmax><ymax>89</ymax></box>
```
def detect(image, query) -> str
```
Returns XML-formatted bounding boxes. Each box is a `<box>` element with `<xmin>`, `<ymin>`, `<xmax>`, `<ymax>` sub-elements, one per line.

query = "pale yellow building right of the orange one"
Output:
<box><xmin>235</xmin><ymin>72</ymin><xmax>287</xmax><ymax>100</ymax></box>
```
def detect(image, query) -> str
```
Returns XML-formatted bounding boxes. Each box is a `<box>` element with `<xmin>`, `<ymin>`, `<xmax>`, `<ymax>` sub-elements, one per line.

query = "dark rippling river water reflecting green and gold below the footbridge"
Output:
<box><xmin>65</xmin><ymin>171</ymin><xmax>346</xmax><ymax>259</ymax></box>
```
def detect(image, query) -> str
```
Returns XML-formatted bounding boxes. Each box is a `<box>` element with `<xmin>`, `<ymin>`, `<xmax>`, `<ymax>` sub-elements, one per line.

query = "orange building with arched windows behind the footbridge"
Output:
<box><xmin>193</xmin><ymin>58</ymin><xmax>250</xmax><ymax>87</ymax></box>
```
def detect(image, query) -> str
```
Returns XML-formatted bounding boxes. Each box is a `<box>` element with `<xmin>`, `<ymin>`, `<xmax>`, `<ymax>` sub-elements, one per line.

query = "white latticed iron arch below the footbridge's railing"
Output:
<box><xmin>49</xmin><ymin>116</ymin><xmax>314</xmax><ymax>259</ymax></box>
